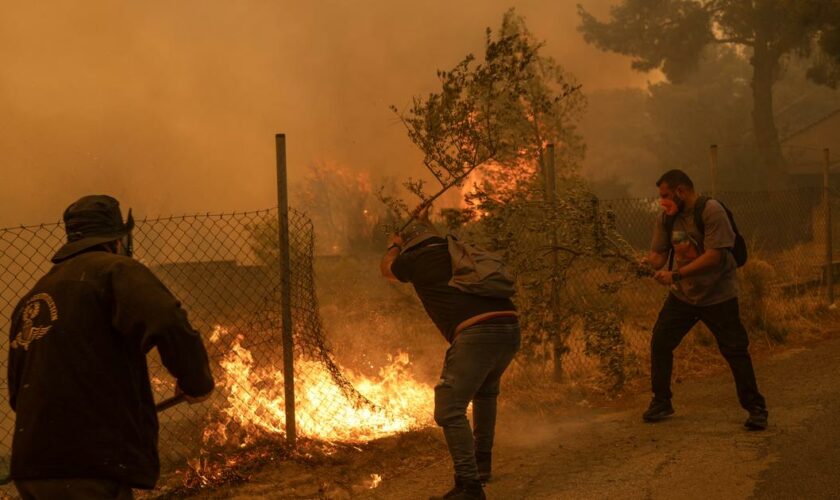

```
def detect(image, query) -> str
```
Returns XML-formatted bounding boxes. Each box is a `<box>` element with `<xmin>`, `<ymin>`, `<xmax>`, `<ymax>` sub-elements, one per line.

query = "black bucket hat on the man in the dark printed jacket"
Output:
<box><xmin>52</xmin><ymin>194</ymin><xmax>134</xmax><ymax>262</ymax></box>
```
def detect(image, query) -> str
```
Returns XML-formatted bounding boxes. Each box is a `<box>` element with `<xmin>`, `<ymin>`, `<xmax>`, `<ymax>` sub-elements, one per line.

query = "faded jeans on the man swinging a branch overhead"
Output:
<box><xmin>435</xmin><ymin>324</ymin><xmax>519</xmax><ymax>480</ymax></box>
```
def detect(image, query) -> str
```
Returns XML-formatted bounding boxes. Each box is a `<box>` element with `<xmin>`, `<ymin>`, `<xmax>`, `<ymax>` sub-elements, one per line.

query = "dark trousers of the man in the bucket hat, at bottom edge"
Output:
<box><xmin>15</xmin><ymin>479</ymin><xmax>134</xmax><ymax>500</ymax></box>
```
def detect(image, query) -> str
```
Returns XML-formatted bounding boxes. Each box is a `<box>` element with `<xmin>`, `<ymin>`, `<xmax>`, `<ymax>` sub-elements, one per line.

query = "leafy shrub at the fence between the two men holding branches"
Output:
<box><xmin>452</xmin><ymin>176</ymin><xmax>638</xmax><ymax>390</ymax></box>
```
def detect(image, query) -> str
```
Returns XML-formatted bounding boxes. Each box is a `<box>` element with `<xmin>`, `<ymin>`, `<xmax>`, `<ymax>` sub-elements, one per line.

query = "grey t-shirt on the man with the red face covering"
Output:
<box><xmin>650</xmin><ymin>200</ymin><xmax>738</xmax><ymax>306</ymax></box>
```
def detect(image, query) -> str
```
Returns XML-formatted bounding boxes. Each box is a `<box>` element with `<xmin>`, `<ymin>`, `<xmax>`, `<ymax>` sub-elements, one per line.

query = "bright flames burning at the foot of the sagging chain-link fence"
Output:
<box><xmin>204</xmin><ymin>328</ymin><xmax>434</xmax><ymax>447</ymax></box>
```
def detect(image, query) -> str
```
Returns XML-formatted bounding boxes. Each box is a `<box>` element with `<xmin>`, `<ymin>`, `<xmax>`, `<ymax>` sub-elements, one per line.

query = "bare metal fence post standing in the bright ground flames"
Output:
<box><xmin>274</xmin><ymin>134</ymin><xmax>297</xmax><ymax>447</ymax></box>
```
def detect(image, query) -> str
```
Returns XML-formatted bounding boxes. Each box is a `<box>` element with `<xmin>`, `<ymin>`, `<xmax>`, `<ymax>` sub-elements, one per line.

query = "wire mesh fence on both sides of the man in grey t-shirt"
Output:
<box><xmin>502</xmin><ymin>187</ymin><xmax>840</xmax><ymax>385</ymax></box>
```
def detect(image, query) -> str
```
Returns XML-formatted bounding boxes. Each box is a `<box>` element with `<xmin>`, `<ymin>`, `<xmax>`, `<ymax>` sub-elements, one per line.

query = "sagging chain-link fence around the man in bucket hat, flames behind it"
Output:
<box><xmin>0</xmin><ymin>210</ymin><xmax>388</xmax><ymax>492</ymax></box>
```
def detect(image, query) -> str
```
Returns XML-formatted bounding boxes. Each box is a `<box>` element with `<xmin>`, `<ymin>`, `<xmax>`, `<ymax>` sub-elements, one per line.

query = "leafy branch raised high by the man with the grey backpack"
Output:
<box><xmin>380</xmin><ymin>10</ymin><xmax>584</xmax><ymax>228</ymax></box>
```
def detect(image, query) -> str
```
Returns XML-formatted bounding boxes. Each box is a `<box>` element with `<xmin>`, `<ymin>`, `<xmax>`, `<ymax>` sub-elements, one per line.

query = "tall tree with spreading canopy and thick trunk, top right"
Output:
<box><xmin>578</xmin><ymin>0</ymin><xmax>840</xmax><ymax>187</ymax></box>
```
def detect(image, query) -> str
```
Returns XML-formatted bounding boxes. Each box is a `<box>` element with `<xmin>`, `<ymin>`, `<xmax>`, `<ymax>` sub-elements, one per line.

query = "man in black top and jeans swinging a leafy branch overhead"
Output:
<box><xmin>381</xmin><ymin>220</ymin><xmax>520</xmax><ymax>499</ymax></box>
